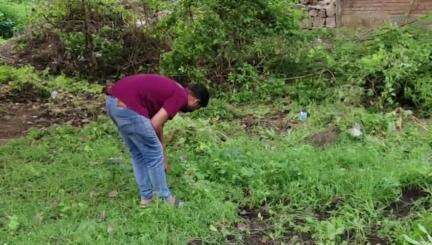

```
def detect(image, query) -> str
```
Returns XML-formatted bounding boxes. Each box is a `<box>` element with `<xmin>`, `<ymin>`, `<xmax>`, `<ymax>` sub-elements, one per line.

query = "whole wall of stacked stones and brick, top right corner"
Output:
<box><xmin>301</xmin><ymin>0</ymin><xmax>432</xmax><ymax>27</ymax></box>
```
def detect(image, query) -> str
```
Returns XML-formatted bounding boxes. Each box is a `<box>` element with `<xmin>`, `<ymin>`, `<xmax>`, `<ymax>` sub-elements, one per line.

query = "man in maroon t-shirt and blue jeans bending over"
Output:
<box><xmin>106</xmin><ymin>74</ymin><xmax>209</xmax><ymax>207</ymax></box>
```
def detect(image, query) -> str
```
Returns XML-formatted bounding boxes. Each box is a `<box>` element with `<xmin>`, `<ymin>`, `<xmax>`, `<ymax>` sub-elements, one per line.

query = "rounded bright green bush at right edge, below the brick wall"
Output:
<box><xmin>359</xmin><ymin>22</ymin><xmax>432</xmax><ymax>113</ymax></box>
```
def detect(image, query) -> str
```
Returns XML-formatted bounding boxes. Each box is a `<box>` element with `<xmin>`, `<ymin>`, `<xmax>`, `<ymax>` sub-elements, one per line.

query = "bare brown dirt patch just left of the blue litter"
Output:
<box><xmin>241</xmin><ymin>112</ymin><xmax>299</xmax><ymax>134</ymax></box>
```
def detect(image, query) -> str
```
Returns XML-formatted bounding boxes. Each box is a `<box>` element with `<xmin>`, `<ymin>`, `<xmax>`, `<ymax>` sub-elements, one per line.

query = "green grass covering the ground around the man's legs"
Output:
<box><xmin>0</xmin><ymin>103</ymin><xmax>432</xmax><ymax>244</ymax></box>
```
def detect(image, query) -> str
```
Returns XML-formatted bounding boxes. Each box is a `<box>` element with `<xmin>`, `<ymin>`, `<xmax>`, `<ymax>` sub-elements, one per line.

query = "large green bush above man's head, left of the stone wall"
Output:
<box><xmin>161</xmin><ymin>0</ymin><xmax>301</xmax><ymax>85</ymax></box>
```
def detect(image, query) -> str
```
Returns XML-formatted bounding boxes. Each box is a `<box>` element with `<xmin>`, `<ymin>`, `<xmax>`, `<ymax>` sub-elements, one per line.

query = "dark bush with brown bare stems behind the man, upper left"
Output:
<box><xmin>17</xmin><ymin>0</ymin><xmax>165</xmax><ymax>79</ymax></box>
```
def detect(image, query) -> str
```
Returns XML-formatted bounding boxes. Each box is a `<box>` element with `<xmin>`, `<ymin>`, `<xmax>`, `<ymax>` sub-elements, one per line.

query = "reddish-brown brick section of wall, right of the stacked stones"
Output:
<box><xmin>339</xmin><ymin>0</ymin><xmax>432</xmax><ymax>26</ymax></box>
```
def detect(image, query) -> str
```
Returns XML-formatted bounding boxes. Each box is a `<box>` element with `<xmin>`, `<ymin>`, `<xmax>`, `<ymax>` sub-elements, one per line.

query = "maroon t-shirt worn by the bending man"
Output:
<box><xmin>108</xmin><ymin>74</ymin><xmax>188</xmax><ymax>119</ymax></box>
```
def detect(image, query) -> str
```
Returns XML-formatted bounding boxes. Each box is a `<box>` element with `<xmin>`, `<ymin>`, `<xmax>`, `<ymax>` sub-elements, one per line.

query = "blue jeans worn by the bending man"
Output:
<box><xmin>106</xmin><ymin>96</ymin><xmax>171</xmax><ymax>199</ymax></box>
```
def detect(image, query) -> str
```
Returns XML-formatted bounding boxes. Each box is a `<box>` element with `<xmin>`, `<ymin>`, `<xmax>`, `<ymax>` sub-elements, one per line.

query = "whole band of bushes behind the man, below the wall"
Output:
<box><xmin>5</xmin><ymin>0</ymin><xmax>432</xmax><ymax>117</ymax></box>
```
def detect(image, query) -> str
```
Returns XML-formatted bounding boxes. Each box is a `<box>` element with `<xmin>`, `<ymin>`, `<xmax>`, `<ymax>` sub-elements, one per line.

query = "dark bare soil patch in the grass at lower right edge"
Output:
<box><xmin>386</xmin><ymin>185</ymin><xmax>430</xmax><ymax>218</ymax></box>
